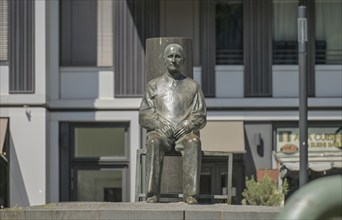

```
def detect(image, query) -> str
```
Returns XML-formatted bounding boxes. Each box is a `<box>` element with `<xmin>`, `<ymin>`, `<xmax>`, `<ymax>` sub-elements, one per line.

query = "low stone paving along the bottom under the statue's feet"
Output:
<box><xmin>0</xmin><ymin>202</ymin><xmax>281</xmax><ymax>220</ymax></box>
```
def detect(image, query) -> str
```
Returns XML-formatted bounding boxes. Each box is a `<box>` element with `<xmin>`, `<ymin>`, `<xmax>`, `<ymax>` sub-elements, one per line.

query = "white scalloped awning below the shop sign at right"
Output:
<box><xmin>274</xmin><ymin>151</ymin><xmax>342</xmax><ymax>172</ymax></box>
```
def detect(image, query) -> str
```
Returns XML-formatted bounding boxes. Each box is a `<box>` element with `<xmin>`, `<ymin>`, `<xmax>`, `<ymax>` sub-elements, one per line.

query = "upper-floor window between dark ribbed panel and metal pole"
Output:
<box><xmin>273</xmin><ymin>0</ymin><xmax>298</xmax><ymax>64</ymax></box>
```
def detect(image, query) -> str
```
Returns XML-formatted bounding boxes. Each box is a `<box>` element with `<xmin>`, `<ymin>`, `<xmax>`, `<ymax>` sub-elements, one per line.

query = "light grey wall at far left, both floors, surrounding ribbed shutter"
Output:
<box><xmin>0</xmin><ymin>1</ymin><xmax>48</xmax><ymax>206</ymax></box>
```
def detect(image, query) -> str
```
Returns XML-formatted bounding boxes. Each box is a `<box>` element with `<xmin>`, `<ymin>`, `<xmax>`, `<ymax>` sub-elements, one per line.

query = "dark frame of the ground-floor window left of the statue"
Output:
<box><xmin>59</xmin><ymin>121</ymin><xmax>130</xmax><ymax>202</ymax></box>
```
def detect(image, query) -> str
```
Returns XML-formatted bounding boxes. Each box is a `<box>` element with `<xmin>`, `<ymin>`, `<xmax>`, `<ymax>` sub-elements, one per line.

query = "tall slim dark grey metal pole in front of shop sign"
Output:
<box><xmin>298</xmin><ymin>6</ymin><xmax>308</xmax><ymax>187</ymax></box>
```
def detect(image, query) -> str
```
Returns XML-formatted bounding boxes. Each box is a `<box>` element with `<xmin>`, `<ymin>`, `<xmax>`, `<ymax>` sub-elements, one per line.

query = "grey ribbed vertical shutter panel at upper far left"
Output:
<box><xmin>8</xmin><ymin>0</ymin><xmax>35</xmax><ymax>93</ymax></box>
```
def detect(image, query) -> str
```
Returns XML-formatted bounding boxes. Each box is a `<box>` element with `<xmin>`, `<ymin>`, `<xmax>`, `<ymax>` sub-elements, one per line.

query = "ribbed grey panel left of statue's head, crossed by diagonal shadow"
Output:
<box><xmin>113</xmin><ymin>0</ymin><xmax>159</xmax><ymax>96</ymax></box>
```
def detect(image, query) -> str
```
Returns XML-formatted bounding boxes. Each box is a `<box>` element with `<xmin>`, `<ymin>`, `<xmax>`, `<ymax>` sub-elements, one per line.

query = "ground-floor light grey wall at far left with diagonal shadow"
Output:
<box><xmin>0</xmin><ymin>107</ymin><xmax>47</xmax><ymax>207</ymax></box>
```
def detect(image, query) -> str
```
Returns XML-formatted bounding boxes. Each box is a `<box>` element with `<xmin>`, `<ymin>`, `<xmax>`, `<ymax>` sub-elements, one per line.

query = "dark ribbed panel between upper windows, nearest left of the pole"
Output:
<box><xmin>243</xmin><ymin>0</ymin><xmax>272</xmax><ymax>96</ymax></box>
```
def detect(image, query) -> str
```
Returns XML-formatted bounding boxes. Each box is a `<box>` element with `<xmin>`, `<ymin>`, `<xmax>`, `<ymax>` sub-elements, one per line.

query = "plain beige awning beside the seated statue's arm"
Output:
<box><xmin>201</xmin><ymin>121</ymin><xmax>245</xmax><ymax>153</ymax></box>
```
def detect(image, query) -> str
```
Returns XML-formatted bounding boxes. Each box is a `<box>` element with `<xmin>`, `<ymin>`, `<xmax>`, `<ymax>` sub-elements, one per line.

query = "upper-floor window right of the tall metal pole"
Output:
<box><xmin>315</xmin><ymin>0</ymin><xmax>342</xmax><ymax>64</ymax></box>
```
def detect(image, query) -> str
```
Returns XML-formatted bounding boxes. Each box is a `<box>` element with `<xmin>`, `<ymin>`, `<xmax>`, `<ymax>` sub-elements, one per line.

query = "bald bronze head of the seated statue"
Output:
<box><xmin>163</xmin><ymin>44</ymin><xmax>185</xmax><ymax>75</ymax></box>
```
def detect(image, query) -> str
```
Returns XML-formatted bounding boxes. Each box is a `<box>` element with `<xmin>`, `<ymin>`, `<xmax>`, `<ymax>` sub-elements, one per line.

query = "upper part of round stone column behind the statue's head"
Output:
<box><xmin>145</xmin><ymin>37</ymin><xmax>193</xmax><ymax>83</ymax></box>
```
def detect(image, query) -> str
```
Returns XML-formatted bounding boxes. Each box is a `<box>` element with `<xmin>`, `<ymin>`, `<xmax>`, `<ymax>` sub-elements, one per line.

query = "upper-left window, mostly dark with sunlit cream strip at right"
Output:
<box><xmin>60</xmin><ymin>0</ymin><xmax>113</xmax><ymax>66</ymax></box>
